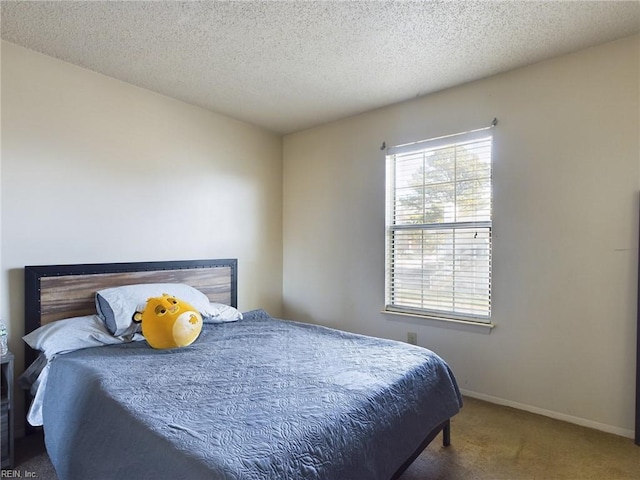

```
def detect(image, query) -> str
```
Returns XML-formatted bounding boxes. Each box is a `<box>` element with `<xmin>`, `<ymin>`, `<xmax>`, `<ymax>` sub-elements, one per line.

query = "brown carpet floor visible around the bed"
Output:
<box><xmin>3</xmin><ymin>398</ymin><xmax>640</xmax><ymax>480</ymax></box>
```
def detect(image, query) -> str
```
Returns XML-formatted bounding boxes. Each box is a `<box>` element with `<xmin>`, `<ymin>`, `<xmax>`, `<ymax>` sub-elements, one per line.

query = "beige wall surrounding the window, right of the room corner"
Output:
<box><xmin>283</xmin><ymin>36</ymin><xmax>640</xmax><ymax>436</ymax></box>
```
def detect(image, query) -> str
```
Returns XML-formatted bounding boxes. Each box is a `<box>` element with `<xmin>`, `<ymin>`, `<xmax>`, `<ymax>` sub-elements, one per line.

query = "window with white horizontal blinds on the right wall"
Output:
<box><xmin>385</xmin><ymin>128</ymin><xmax>492</xmax><ymax>323</ymax></box>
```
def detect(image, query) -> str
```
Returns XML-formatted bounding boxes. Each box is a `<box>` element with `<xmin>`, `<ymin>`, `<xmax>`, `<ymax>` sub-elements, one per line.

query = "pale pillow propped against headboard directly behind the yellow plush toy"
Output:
<box><xmin>96</xmin><ymin>283</ymin><xmax>209</xmax><ymax>335</ymax></box>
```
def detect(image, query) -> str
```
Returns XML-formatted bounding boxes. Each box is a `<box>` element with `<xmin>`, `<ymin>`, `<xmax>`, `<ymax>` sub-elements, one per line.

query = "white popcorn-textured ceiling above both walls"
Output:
<box><xmin>0</xmin><ymin>1</ymin><xmax>640</xmax><ymax>133</ymax></box>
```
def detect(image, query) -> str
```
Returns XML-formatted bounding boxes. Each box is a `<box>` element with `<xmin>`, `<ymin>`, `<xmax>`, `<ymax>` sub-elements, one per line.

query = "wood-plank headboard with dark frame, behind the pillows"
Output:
<box><xmin>24</xmin><ymin>259</ymin><xmax>238</xmax><ymax>365</ymax></box>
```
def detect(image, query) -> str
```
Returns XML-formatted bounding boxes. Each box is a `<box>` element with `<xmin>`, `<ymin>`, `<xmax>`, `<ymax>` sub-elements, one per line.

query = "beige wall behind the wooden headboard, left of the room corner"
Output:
<box><xmin>0</xmin><ymin>42</ymin><xmax>282</xmax><ymax>430</ymax></box>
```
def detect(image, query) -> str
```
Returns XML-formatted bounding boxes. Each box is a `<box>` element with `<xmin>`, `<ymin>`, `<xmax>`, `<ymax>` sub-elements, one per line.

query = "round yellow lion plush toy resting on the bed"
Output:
<box><xmin>133</xmin><ymin>293</ymin><xmax>202</xmax><ymax>348</ymax></box>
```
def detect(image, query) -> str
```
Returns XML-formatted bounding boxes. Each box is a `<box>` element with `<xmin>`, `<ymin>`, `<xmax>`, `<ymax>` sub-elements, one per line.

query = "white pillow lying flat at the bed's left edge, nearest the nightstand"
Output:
<box><xmin>22</xmin><ymin>315</ymin><xmax>133</xmax><ymax>359</ymax></box>
